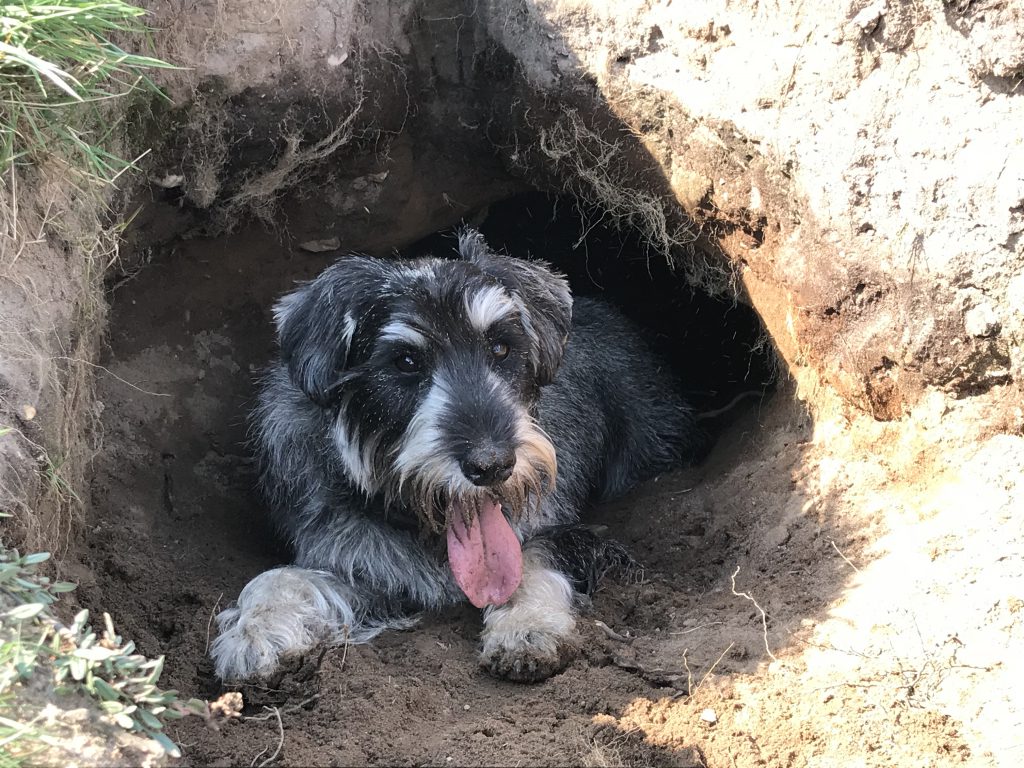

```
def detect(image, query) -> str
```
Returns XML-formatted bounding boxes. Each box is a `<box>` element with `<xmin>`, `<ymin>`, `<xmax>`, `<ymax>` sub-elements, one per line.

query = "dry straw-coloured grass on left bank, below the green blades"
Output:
<box><xmin>0</xmin><ymin>154</ymin><xmax>120</xmax><ymax>555</ymax></box>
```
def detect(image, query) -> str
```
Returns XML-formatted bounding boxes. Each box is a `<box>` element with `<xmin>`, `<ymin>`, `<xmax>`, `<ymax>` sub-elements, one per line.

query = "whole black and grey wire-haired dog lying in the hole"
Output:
<box><xmin>211</xmin><ymin>229</ymin><xmax>699</xmax><ymax>680</ymax></box>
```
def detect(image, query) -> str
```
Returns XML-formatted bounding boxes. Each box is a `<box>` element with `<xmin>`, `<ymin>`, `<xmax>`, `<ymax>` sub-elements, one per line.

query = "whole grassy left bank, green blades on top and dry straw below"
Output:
<box><xmin>0</xmin><ymin>0</ymin><xmax>166</xmax><ymax>555</ymax></box>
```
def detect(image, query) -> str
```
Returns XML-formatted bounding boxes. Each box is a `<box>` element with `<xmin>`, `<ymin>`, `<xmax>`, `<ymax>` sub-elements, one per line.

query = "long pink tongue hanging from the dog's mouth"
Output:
<box><xmin>447</xmin><ymin>501</ymin><xmax>522</xmax><ymax>608</ymax></box>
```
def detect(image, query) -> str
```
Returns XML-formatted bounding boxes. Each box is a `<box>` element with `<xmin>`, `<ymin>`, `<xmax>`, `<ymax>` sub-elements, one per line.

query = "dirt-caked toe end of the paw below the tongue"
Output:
<box><xmin>480</xmin><ymin>630</ymin><xmax>577</xmax><ymax>683</ymax></box>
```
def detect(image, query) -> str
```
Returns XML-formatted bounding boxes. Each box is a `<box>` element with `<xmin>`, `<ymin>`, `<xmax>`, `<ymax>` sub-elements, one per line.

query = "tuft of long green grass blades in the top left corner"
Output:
<box><xmin>0</xmin><ymin>0</ymin><xmax>170</xmax><ymax>182</ymax></box>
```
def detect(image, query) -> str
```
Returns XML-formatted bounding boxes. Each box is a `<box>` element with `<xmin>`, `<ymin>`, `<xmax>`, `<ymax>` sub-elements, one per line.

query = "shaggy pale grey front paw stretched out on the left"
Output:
<box><xmin>210</xmin><ymin>566</ymin><xmax>385</xmax><ymax>680</ymax></box>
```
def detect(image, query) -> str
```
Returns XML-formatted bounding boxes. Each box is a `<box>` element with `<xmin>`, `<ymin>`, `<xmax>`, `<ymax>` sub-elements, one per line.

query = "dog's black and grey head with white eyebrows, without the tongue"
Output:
<box><xmin>274</xmin><ymin>230</ymin><xmax>571</xmax><ymax>531</ymax></box>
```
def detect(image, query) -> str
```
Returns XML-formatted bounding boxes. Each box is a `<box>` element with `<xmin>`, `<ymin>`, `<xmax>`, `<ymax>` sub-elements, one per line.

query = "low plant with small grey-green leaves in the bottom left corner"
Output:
<box><xmin>0</xmin><ymin>551</ymin><xmax>210</xmax><ymax>766</ymax></box>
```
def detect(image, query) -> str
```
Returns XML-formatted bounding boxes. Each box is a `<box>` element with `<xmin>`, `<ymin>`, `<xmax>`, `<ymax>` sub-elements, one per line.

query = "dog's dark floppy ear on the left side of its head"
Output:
<box><xmin>273</xmin><ymin>256</ymin><xmax>385</xmax><ymax>408</ymax></box>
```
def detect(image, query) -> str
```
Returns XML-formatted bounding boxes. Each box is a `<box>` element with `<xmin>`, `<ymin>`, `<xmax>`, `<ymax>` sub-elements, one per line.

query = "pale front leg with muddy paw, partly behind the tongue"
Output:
<box><xmin>480</xmin><ymin>541</ymin><xmax>577</xmax><ymax>683</ymax></box>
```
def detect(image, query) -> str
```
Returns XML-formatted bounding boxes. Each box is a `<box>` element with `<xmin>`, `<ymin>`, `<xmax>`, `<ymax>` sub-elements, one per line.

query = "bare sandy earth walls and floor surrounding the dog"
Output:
<box><xmin>0</xmin><ymin>0</ymin><xmax>1024</xmax><ymax>767</ymax></box>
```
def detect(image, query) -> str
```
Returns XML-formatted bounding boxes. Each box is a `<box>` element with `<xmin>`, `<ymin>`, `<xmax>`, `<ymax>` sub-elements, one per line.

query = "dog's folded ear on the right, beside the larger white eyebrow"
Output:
<box><xmin>459</xmin><ymin>227</ymin><xmax>572</xmax><ymax>386</ymax></box>
